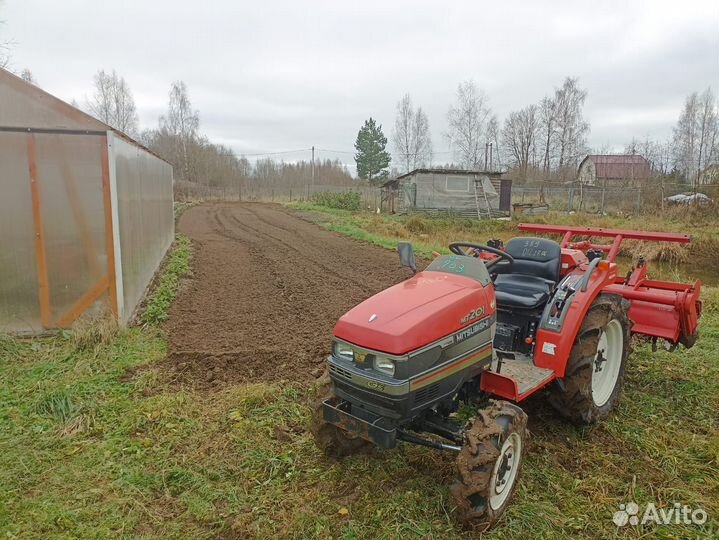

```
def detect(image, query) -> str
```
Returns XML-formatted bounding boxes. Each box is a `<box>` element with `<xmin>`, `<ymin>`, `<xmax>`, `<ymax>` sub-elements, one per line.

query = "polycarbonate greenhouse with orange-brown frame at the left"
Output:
<box><xmin>0</xmin><ymin>69</ymin><xmax>174</xmax><ymax>333</ymax></box>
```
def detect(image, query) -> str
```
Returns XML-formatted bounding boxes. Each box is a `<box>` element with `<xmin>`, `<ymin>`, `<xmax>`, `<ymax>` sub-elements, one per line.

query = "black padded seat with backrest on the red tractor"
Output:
<box><xmin>494</xmin><ymin>238</ymin><xmax>562</xmax><ymax>309</ymax></box>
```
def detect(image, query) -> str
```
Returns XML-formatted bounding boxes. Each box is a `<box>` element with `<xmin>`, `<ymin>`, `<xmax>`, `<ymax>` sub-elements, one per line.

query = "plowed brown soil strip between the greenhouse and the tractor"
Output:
<box><xmin>163</xmin><ymin>203</ymin><xmax>408</xmax><ymax>388</ymax></box>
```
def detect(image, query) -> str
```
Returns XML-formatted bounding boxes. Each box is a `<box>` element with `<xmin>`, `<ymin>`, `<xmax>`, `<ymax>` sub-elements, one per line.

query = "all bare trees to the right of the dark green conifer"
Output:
<box><xmin>392</xmin><ymin>77</ymin><xmax>719</xmax><ymax>191</ymax></box>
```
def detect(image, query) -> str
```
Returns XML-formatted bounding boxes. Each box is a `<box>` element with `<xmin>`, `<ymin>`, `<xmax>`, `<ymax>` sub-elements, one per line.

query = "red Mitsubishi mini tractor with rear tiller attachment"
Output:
<box><xmin>313</xmin><ymin>224</ymin><xmax>701</xmax><ymax>528</ymax></box>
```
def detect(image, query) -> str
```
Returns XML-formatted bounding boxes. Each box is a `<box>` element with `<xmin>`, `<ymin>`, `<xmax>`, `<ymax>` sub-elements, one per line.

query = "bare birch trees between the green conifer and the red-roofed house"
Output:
<box><xmin>382</xmin><ymin>77</ymin><xmax>589</xmax><ymax>181</ymax></box>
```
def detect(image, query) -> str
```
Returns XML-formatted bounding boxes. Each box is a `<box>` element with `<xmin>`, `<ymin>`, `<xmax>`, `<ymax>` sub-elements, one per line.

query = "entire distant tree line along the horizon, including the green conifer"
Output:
<box><xmin>0</xmin><ymin>37</ymin><xmax>719</xmax><ymax>193</ymax></box>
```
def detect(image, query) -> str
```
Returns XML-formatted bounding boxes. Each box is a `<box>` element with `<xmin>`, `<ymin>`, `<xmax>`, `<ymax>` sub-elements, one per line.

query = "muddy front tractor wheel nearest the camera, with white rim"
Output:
<box><xmin>450</xmin><ymin>400</ymin><xmax>527</xmax><ymax>530</ymax></box>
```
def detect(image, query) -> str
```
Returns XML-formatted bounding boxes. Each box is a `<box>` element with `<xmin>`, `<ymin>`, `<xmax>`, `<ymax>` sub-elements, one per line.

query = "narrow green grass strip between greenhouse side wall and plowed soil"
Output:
<box><xmin>141</xmin><ymin>234</ymin><xmax>191</xmax><ymax>324</ymax></box>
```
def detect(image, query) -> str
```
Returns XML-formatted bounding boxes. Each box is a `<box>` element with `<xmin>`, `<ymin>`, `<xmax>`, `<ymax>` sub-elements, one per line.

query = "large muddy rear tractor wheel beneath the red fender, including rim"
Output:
<box><xmin>550</xmin><ymin>294</ymin><xmax>632</xmax><ymax>424</ymax></box>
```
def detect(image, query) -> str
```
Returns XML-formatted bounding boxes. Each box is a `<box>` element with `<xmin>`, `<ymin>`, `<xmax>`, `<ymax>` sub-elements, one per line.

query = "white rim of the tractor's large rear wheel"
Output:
<box><xmin>592</xmin><ymin>319</ymin><xmax>624</xmax><ymax>407</ymax></box>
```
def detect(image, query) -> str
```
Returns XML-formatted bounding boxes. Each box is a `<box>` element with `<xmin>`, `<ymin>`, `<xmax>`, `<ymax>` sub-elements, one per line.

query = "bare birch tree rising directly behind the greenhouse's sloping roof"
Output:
<box><xmin>87</xmin><ymin>69</ymin><xmax>138</xmax><ymax>137</ymax></box>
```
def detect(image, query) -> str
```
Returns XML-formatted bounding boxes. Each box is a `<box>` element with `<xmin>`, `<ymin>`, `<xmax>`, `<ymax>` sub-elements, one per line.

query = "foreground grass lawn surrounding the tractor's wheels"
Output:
<box><xmin>0</xmin><ymin>218</ymin><xmax>719</xmax><ymax>540</ymax></box>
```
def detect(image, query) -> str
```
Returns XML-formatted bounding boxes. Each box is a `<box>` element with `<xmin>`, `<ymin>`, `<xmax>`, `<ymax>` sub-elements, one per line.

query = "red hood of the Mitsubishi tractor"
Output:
<box><xmin>334</xmin><ymin>271</ymin><xmax>495</xmax><ymax>355</ymax></box>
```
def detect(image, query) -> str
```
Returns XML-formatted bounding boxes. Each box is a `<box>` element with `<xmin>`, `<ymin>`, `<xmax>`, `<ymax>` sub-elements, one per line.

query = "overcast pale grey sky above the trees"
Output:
<box><xmin>0</xmin><ymin>0</ymin><xmax>719</xmax><ymax>167</ymax></box>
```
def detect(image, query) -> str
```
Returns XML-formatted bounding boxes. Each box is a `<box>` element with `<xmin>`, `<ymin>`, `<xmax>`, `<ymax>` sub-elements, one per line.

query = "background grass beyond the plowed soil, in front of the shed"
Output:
<box><xmin>288</xmin><ymin>203</ymin><xmax>719</xmax><ymax>284</ymax></box>
